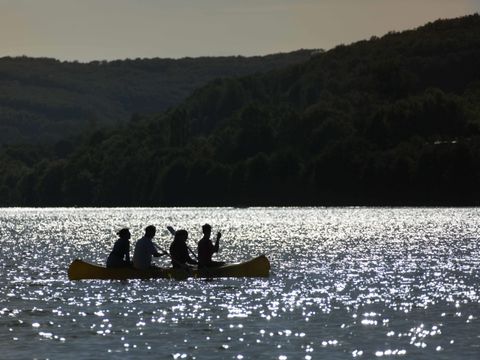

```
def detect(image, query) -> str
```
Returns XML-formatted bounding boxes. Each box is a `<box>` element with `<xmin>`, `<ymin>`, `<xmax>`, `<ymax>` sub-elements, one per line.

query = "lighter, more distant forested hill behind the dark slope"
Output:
<box><xmin>0</xmin><ymin>50</ymin><xmax>312</xmax><ymax>144</ymax></box>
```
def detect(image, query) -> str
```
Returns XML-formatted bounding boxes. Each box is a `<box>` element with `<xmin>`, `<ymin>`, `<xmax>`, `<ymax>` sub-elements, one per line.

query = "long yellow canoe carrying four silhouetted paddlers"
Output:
<box><xmin>68</xmin><ymin>255</ymin><xmax>270</xmax><ymax>280</ymax></box>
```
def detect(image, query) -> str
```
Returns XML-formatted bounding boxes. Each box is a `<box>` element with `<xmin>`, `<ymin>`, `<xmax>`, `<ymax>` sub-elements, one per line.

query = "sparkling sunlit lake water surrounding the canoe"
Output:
<box><xmin>0</xmin><ymin>208</ymin><xmax>480</xmax><ymax>360</ymax></box>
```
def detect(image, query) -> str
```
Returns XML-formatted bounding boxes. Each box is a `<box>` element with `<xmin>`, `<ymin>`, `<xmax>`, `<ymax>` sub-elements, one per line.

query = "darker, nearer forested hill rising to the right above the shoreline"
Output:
<box><xmin>0</xmin><ymin>15</ymin><xmax>480</xmax><ymax>206</ymax></box>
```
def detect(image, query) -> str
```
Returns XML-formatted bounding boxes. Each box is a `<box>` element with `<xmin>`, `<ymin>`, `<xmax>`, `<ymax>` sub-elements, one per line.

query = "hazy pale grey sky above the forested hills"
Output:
<box><xmin>0</xmin><ymin>0</ymin><xmax>480</xmax><ymax>61</ymax></box>
